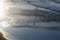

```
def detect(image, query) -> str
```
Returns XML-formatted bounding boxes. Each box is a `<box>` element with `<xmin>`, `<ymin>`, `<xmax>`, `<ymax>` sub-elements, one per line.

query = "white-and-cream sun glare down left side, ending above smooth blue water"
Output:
<box><xmin>0</xmin><ymin>0</ymin><xmax>13</xmax><ymax>27</ymax></box>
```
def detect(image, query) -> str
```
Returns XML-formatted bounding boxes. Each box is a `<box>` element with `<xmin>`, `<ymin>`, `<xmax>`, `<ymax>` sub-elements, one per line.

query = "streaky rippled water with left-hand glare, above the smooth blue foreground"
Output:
<box><xmin>0</xmin><ymin>0</ymin><xmax>60</xmax><ymax>27</ymax></box>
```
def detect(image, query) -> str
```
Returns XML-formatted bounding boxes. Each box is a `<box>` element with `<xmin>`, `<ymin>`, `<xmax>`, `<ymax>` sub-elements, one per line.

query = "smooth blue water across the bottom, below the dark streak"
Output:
<box><xmin>4</xmin><ymin>28</ymin><xmax>60</xmax><ymax>40</ymax></box>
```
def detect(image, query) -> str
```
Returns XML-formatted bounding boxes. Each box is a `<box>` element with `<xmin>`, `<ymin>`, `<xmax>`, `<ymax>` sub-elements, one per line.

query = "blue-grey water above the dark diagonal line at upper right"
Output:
<box><xmin>22</xmin><ymin>0</ymin><xmax>60</xmax><ymax>12</ymax></box>
